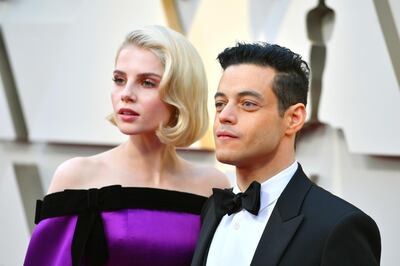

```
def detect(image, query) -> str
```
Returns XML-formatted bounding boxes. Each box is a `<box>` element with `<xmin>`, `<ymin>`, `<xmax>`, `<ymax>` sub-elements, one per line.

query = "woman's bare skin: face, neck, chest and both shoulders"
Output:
<box><xmin>48</xmin><ymin>45</ymin><xmax>230</xmax><ymax>197</ymax></box>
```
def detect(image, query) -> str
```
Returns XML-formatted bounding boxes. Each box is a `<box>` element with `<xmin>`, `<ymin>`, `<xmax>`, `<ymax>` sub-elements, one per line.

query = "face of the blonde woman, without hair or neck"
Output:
<box><xmin>111</xmin><ymin>45</ymin><xmax>171</xmax><ymax>135</ymax></box>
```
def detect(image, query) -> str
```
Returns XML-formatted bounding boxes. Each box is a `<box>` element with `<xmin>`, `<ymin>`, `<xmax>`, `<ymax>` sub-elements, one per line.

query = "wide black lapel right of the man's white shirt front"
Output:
<box><xmin>251</xmin><ymin>164</ymin><xmax>312</xmax><ymax>266</ymax></box>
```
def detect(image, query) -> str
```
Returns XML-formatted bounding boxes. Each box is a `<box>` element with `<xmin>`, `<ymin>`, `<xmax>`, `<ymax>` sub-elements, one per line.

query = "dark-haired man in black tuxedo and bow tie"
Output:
<box><xmin>192</xmin><ymin>43</ymin><xmax>381</xmax><ymax>266</ymax></box>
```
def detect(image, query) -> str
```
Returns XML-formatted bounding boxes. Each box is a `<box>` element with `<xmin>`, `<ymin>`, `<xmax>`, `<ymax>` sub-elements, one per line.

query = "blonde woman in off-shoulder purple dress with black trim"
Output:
<box><xmin>25</xmin><ymin>26</ymin><xmax>229</xmax><ymax>265</ymax></box>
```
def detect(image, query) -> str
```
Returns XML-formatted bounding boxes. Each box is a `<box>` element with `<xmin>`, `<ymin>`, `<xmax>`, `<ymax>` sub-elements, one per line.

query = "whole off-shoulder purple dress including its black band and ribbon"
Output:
<box><xmin>24</xmin><ymin>185</ymin><xmax>206</xmax><ymax>266</ymax></box>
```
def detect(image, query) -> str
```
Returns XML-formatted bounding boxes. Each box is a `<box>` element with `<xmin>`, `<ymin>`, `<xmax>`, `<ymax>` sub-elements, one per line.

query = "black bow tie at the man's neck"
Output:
<box><xmin>213</xmin><ymin>181</ymin><xmax>261</xmax><ymax>219</ymax></box>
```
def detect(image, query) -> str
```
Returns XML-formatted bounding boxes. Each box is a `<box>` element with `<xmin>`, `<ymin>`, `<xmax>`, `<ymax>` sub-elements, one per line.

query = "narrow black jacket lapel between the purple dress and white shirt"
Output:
<box><xmin>191</xmin><ymin>199</ymin><xmax>221</xmax><ymax>266</ymax></box>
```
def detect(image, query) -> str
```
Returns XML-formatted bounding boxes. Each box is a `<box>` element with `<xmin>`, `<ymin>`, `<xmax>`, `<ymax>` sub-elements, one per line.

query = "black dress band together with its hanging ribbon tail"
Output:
<box><xmin>35</xmin><ymin>185</ymin><xmax>207</xmax><ymax>266</ymax></box>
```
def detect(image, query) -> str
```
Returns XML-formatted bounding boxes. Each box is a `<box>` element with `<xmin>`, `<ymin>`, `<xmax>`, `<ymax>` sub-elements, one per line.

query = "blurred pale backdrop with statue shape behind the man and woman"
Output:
<box><xmin>0</xmin><ymin>0</ymin><xmax>400</xmax><ymax>266</ymax></box>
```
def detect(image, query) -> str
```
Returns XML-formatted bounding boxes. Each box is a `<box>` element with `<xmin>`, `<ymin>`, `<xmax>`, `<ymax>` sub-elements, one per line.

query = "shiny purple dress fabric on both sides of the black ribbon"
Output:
<box><xmin>24</xmin><ymin>209</ymin><xmax>200</xmax><ymax>266</ymax></box>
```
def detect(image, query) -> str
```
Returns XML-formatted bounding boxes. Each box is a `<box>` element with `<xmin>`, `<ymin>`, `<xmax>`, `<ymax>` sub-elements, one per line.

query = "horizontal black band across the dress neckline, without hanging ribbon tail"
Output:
<box><xmin>35</xmin><ymin>185</ymin><xmax>207</xmax><ymax>224</ymax></box>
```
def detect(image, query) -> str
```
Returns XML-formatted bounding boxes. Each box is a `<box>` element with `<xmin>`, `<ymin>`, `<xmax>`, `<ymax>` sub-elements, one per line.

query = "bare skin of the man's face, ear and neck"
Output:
<box><xmin>214</xmin><ymin>64</ymin><xmax>306</xmax><ymax>191</ymax></box>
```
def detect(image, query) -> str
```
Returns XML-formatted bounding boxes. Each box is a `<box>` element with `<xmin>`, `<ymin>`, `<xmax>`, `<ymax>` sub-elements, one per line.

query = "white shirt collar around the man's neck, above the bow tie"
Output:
<box><xmin>233</xmin><ymin>160</ymin><xmax>298</xmax><ymax>211</ymax></box>
